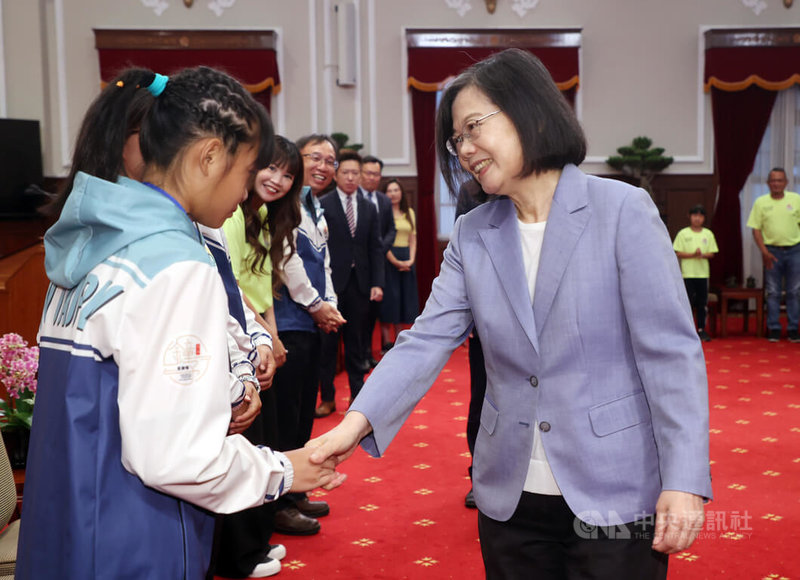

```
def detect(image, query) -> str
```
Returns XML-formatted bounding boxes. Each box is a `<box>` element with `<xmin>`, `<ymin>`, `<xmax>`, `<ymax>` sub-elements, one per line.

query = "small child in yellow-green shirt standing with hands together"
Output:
<box><xmin>672</xmin><ymin>205</ymin><xmax>719</xmax><ymax>342</ymax></box>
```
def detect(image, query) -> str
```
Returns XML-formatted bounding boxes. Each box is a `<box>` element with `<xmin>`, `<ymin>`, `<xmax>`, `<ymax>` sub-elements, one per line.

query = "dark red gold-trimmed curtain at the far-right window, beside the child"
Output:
<box><xmin>705</xmin><ymin>42</ymin><xmax>800</xmax><ymax>286</ymax></box>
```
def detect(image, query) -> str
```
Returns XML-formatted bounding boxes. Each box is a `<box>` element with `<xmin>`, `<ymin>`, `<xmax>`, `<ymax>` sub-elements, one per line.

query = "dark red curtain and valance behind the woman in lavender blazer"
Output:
<box><xmin>408</xmin><ymin>46</ymin><xmax>579</xmax><ymax>304</ymax></box>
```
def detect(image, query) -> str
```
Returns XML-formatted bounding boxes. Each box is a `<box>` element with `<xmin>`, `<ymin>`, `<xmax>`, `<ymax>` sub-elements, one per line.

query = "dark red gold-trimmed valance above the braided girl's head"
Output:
<box><xmin>98</xmin><ymin>48</ymin><xmax>281</xmax><ymax>111</ymax></box>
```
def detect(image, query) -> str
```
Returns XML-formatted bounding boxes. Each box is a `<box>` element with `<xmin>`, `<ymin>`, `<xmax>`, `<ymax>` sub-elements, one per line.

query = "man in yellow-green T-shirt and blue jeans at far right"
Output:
<box><xmin>747</xmin><ymin>167</ymin><xmax>800</xmax><ymax>342</ymax></box>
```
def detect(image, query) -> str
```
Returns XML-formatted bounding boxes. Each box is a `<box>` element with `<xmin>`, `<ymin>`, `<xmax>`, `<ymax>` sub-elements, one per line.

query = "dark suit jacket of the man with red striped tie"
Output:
<box><xmin>319</xmin><ymin>190</ymin><xmax>385</xmax><ymax>295</ymax></box>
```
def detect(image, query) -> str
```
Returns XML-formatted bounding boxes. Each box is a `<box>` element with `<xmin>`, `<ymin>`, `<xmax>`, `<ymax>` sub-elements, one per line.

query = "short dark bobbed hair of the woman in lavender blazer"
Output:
<box><xmin>436</xmin><ymin>48</ymin><xmax>586</xmax><ymax>197</ymax></box>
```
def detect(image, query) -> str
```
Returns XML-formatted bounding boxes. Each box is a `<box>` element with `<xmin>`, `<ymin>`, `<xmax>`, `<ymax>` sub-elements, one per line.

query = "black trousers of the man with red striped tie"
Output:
<box><xmin>320</xmin><ymin>270</ymin><xmax>370</xmax><ymax>401</ymax></box>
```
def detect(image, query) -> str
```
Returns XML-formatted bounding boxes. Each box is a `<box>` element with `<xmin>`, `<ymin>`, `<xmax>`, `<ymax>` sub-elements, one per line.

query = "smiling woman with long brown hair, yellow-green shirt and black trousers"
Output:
<box><xmin>222</xmin><ymin>135</ymin><xmax>302</xmax><ymax>578</ymax></box>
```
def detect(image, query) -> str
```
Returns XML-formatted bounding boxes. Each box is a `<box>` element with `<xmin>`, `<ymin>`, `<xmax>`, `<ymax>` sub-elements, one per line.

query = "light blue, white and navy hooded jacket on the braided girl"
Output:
<box><xmin>17</xmin><ymin>174</ymin><xmax>294</xmax><ymax>580</ymax></box>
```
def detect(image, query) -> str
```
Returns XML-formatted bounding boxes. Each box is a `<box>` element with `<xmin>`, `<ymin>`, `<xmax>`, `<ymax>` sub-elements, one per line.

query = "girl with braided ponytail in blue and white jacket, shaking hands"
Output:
<box><xmin>17</xmin><ymin>67</ymin><xmax>341</xmax><ymax>579</ymax></box>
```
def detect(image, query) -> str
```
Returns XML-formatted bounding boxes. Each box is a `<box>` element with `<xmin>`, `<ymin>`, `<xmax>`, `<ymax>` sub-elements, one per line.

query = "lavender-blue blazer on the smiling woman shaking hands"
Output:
<box><xmin>351</xmin><ymin>165</ymin><xmax>711</xmax><ymax>525</ymax></box>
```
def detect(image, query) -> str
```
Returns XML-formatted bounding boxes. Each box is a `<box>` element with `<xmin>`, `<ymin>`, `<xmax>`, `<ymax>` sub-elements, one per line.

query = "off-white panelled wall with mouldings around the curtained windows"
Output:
<box><xmin>0</xmin><ymin>0</ymin><xmax>800</xmax><ymax>175</ymax></box>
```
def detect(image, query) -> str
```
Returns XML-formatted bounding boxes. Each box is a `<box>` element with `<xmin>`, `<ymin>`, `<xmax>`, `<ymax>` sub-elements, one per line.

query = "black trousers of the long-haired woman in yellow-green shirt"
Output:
<box><xmin>207</xmin><ymin>389</ymin><xmax>278</xmax><ymax>578</ymax></box>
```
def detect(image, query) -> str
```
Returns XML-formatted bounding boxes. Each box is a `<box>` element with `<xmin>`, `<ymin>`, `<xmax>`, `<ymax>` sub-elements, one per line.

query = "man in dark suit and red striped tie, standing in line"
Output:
<box><xmin>317</xmin><ymin>151</ymin><xmax>384</xmax><ymax>416</ymax></box>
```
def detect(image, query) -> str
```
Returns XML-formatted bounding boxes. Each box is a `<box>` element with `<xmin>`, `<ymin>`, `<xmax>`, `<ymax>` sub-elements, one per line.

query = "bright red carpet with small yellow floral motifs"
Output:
<box><xmin>220</xmin><ymin>321</ymin><xmax>800</xmax><ymax>580</ymax></box>
